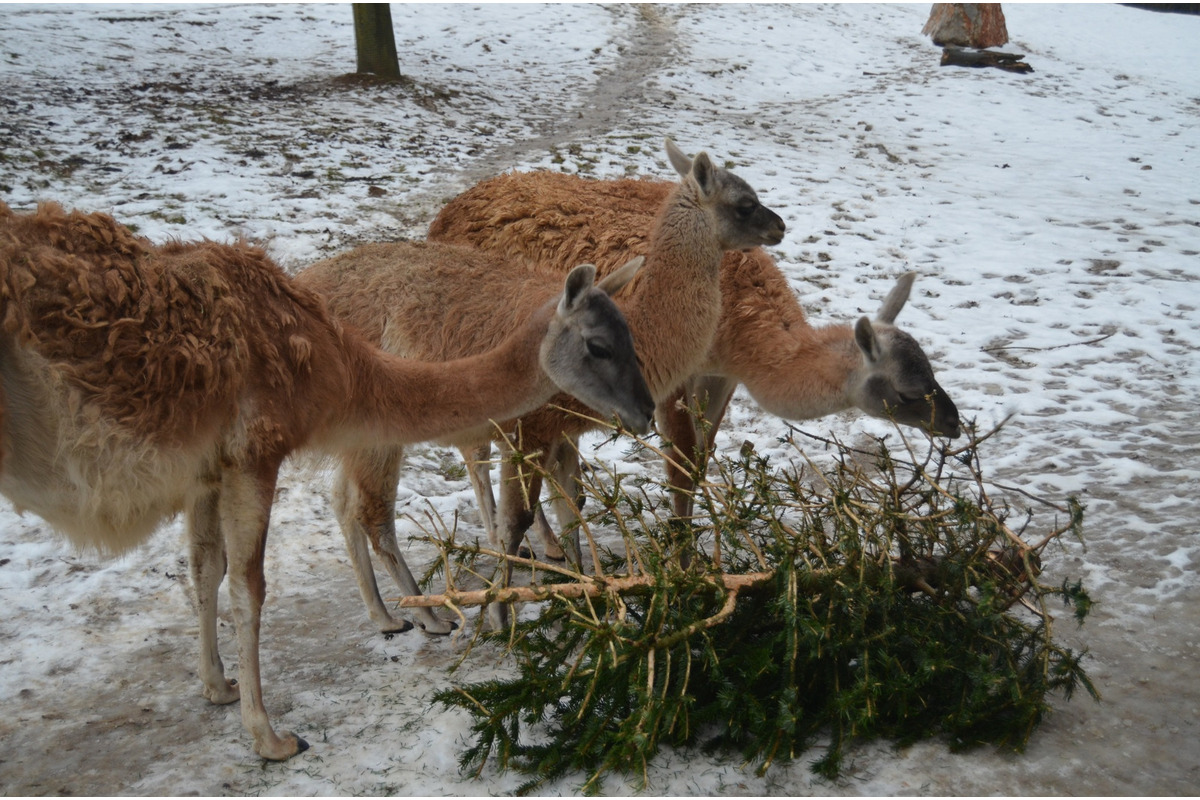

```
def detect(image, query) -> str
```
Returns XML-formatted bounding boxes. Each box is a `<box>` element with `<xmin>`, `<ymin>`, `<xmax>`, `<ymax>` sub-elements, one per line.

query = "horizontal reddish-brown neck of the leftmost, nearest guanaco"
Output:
<box><xmin>341</xmin><ymin>303</ymin><xmax>558</xmax><ymax>445</ymax></box>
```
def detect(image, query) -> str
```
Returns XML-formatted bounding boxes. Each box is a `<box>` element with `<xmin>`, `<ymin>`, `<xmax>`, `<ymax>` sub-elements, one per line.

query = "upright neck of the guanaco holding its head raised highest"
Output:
<box><xmin>622</xmin><ymin>182</ymin><xmax>722</xmax><ymax>399</ymax></box>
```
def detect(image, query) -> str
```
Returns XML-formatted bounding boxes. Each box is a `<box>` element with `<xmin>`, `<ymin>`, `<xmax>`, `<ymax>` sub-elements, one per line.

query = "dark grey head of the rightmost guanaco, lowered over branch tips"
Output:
<box><xmin>851</xmin><ymin>272</ymin><xmax>960</xmax><ymax>439</ymax></box>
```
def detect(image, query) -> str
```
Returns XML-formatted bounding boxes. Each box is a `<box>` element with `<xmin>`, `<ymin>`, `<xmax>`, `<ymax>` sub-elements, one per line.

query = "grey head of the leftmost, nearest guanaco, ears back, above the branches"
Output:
<box><xmin>540</xmin><ymin>257</ymin><xmax>654</xmax><ymax>433</ymax></box>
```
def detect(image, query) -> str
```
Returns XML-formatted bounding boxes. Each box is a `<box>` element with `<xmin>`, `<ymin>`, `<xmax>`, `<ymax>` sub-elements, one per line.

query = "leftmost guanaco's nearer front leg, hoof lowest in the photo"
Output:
<box><xmin>220</xmin><ymin>464</ymin><xmax>308</xmax><ymax>760</ymax></box>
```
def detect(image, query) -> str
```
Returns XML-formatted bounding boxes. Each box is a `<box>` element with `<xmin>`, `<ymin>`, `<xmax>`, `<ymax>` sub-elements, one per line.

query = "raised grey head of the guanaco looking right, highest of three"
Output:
<box><xmin>666</xmin><ymin>139</ymin><xmax>787</xmax><ymax>249</ymax></box>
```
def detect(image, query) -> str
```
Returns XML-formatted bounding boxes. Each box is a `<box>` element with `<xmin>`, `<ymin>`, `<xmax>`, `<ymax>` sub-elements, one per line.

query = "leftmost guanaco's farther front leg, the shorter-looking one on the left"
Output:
<box><xmin>187</xmin><ymin>479</ymin><xmax>240</xmax><ymax>705</ymax></box>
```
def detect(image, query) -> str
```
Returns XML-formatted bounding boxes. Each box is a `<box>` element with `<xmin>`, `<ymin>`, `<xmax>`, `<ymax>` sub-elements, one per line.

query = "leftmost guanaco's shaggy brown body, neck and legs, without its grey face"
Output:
<box><xmin>0</xmin><ymin>204</ymin><xmax>644</xmax><ymax>759</ymax></box>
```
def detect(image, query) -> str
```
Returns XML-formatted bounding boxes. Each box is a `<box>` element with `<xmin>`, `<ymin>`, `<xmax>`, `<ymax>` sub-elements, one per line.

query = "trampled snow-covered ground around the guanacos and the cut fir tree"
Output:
<box><xmin>0</xmin><ymin>5</ymin><xmax>1200</xmax><ymax>795</ymax></box>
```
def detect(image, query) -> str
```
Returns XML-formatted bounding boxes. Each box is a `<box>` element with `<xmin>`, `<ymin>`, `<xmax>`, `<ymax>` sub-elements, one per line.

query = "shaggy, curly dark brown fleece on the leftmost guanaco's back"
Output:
<box><xmin>0</xmin><ymin>203</ymin><xmax>350</xmax><ymax>445</ymax></box>
